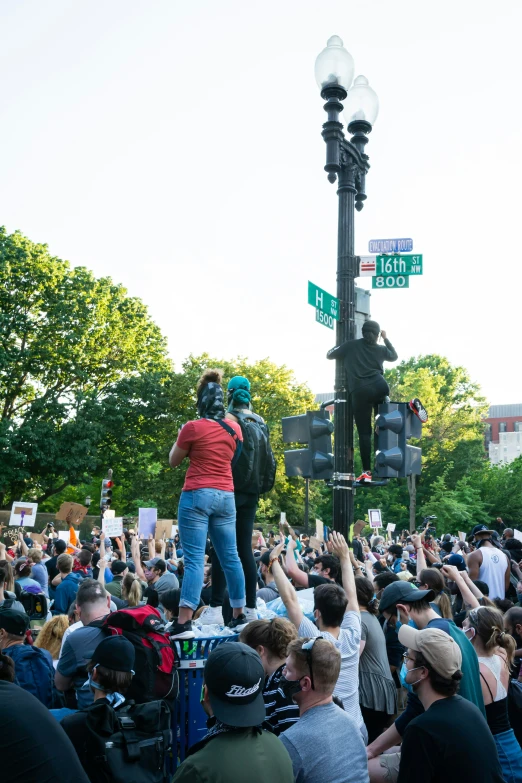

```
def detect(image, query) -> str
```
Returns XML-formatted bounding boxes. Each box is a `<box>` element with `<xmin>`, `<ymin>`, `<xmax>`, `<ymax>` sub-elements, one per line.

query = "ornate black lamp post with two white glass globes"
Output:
<box><xmin>315</xmin><ymin>35</ymin><xmax>379</xmax><ymax>538</ymax></box>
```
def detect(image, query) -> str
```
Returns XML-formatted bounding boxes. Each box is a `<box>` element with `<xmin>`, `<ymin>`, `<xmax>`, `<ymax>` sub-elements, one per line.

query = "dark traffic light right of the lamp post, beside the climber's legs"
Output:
<box><xmin>374</xmin><ymin>402</ymin><xmax>422</xmax><ymax>478</ymax></box>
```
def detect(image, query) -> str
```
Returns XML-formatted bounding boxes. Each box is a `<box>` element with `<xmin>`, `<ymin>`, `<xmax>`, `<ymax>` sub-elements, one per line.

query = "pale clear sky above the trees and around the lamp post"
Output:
<box><xmin>0</xmin><ymin>0</ymin><xmax>522</xmax><ymax>404</ymax></box>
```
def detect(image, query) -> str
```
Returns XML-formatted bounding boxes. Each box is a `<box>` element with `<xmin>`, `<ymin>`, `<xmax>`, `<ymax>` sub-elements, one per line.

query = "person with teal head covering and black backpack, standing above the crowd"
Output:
<box><xmin>199</xmin><ymin>375</ymin><xmax>276</xmax><ymax>625</ymax></box>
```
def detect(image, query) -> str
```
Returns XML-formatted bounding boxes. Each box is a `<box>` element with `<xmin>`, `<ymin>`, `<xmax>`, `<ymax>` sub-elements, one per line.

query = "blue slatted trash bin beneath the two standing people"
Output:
<box><xmin>172</xmin><ymin>634</ymin><xmax>239</xmax><ymax>769</ymax></box>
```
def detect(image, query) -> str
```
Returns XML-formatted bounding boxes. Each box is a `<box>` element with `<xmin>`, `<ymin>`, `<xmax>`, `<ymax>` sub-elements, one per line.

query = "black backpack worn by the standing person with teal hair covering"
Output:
<box><xmin>232</xmin><ymin>411</ymin><xmax>276</xmax><ymax>495</ymax></box>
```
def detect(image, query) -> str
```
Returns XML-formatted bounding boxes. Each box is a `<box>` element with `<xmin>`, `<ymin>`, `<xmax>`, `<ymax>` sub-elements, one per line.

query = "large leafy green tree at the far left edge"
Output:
<box><xmin>0</xmin><ymin>228</ymin><xmax>170</xmax><ymax>508</ymax></box>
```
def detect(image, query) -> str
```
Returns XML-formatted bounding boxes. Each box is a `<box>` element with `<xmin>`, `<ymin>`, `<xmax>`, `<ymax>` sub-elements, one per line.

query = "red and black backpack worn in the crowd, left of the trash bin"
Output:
<box><xmin>101</xmin><ymin>606</ymin><xmax>179</xmax><ymax>704</ymax></box>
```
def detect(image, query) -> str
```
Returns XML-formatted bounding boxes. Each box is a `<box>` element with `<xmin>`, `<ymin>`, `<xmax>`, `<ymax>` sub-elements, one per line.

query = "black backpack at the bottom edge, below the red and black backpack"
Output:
<box><xmin>64</xmin><ymin>700</ymin><xmax>172</xmax><ymax>783</ymax></box>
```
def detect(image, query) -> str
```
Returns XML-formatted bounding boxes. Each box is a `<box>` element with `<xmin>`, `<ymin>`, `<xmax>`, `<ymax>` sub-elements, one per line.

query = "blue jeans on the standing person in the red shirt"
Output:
<box><xmin>178</xmin><ymin>489</ymin><xmax>245</xmax><ymax>611</ymax></box>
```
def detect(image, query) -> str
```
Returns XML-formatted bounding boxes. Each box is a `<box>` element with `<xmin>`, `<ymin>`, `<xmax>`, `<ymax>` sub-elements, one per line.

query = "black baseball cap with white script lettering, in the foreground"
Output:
<box><xmin>204</xmin><ymin>642</ymin><xmax>266</xmax><ymax>727</ymax></box>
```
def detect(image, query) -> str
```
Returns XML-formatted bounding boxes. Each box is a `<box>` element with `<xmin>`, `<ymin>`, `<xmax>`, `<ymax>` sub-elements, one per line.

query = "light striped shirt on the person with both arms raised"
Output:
<box><xmin>298</xmin><ymin>611</ymin><xmax>364</xmax><ymax>727</ymax></box>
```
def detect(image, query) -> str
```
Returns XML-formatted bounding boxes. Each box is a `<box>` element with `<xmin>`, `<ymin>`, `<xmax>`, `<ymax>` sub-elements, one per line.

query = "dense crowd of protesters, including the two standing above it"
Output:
<box><xmin>0</xmin><ymin>371</ymin><xmax>522</xmax><ymax>783</ymax></box>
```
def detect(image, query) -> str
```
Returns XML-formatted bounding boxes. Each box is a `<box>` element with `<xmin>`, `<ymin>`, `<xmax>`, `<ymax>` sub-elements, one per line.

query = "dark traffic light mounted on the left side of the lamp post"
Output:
<box><xmin>282</xmin><ymin>410</ymin><xmax>334</xmax><ymax>479</ymax></box>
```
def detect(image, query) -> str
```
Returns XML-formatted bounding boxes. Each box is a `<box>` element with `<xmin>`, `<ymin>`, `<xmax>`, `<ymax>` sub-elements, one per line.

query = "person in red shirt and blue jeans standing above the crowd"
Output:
<box><xmin>169</xmin><ymin>370</ymin><xmax>246</xmax><ymax>639</ymax></box>
